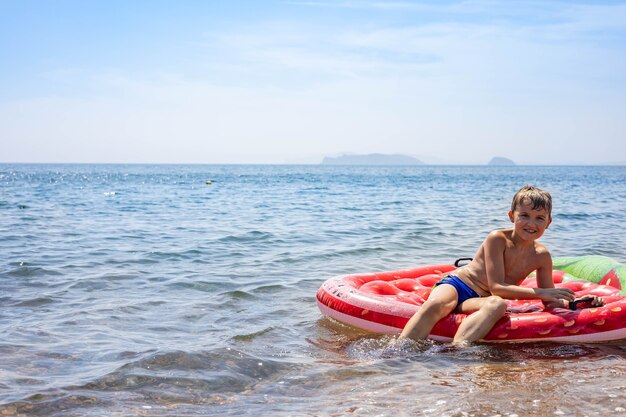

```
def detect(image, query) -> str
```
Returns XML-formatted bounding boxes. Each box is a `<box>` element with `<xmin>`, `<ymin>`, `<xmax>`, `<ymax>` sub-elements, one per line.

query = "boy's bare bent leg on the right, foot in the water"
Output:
<box><xmin>454</xmin><ymin>296</ymin><xmax>506</xmax><ymax>343</ymax></box>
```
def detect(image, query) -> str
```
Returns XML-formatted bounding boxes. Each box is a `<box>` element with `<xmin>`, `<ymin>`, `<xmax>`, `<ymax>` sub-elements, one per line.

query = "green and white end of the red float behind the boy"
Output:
<box><xmin>552</xmin><ymin>255</ymin><xmax>626</xmax><ymax>295</ymax></box>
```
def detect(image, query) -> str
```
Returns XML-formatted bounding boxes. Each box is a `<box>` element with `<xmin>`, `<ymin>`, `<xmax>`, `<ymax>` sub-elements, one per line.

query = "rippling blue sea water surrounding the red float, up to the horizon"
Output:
<box><xmin>0</xmin><ymin>164</ymin><xmax>626</xmax><ymax>417</ymax></box>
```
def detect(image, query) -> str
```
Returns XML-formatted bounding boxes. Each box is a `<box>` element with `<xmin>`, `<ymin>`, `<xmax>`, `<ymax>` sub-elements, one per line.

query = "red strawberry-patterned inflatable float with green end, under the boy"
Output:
<box><xmin>317</xmin><ymin>256</ymin><xmax>626</xmax><ymax>343</ymax></box>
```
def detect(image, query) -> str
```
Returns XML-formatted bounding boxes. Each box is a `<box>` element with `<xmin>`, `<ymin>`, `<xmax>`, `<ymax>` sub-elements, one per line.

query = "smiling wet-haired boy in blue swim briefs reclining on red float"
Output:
<box><xmin>400</xmin><ymin>185</ymin><xmax>603</xmax><ymax>343</ymax></box>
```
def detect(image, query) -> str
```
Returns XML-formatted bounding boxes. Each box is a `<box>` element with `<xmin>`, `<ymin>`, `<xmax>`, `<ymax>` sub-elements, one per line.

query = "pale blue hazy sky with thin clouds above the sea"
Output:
<box><xmin>0</xmin><ymin>0</ymin><xmax>626</xmax><ymax>165</ymax></box>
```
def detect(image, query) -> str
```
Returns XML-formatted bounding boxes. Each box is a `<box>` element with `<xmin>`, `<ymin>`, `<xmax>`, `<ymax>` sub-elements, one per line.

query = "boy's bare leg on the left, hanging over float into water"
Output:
<box><xmin>400</xmin><ymin>284</ymin><xmax>458</xmax><ymax>340</ymax></box>
